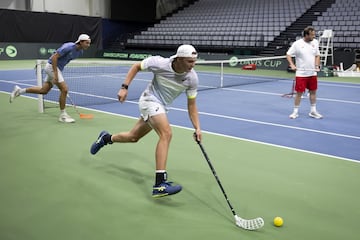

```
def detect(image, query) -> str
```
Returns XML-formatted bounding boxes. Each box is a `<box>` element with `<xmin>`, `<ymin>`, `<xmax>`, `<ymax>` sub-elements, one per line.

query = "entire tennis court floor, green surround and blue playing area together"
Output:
<box><xmin>0</xmin><ymin>58</ymin><xmax>360</xmax><ymax>239</ymax></box>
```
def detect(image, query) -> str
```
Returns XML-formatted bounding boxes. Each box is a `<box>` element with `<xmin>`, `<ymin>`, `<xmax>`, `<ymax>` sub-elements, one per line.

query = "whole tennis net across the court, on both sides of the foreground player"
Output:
<box><xmin>36</xmin><ymin>56</ymin><xmax>285</xmax><ymax>112</ymax></box>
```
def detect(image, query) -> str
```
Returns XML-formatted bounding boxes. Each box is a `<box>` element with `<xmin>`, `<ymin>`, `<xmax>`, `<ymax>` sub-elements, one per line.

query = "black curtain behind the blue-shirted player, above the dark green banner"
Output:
<box><xmin>0</xmin><ymin>9</ymin><xmax>102</xmax><ymax>49</ymax></box>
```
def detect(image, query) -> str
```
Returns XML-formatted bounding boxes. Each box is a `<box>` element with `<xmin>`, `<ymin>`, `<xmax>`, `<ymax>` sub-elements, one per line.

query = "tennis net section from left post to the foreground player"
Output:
<box><xmin>36</xmin><ymin>60</ymin><xmax>146</xmax><ymax>112</ymax></box>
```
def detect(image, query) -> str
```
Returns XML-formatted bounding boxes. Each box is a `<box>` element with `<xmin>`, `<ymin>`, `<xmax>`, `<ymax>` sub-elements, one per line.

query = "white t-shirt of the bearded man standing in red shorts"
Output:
<box><xmin>286</xmin><ymin>39</ymin><xmax>320</xmax><ymax>77</ymax></box>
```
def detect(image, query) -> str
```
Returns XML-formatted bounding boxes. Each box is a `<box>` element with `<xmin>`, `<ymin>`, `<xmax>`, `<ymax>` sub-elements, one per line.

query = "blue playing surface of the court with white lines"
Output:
<box><xmin>0</xmin><ymin>66</ymin><xmax>360</xmax><ymax>161</ymax></box>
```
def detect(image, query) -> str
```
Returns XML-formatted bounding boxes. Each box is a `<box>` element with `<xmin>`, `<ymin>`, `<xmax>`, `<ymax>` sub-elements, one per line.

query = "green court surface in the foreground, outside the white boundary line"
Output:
<box><xmin>0</xmin><ymin>93</ymin><xmax>360</xmax><ymax>240</ymax></box>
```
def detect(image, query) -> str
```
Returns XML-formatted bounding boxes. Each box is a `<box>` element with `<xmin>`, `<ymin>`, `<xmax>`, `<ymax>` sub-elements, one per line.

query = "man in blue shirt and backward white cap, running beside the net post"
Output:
<box><xmin>10</xmin><ymin>34</ymin><xmax>91</xmax><ymax>123</ymax></box>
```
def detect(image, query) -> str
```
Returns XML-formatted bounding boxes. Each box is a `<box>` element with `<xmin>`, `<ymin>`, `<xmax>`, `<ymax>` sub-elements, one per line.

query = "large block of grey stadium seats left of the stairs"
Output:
<box><xmin>128</xmin><ymin>0</ymin><xmax>316</xmax><ymax>48</ymax></box>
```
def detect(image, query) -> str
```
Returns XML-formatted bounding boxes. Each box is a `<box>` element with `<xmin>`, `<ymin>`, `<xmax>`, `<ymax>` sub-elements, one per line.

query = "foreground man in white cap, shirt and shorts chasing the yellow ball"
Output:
<box><xmin>90</xmin><ymin>45</ymin><xmax>201</xmax><ymax>198</ymax></box>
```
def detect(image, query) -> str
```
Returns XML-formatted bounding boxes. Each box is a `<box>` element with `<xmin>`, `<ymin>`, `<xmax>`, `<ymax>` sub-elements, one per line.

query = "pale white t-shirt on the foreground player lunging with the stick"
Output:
<box><xmin>141</xmin><ymin>56</ymin><xmax>199</xmax><ymax>106</ymax></box>
